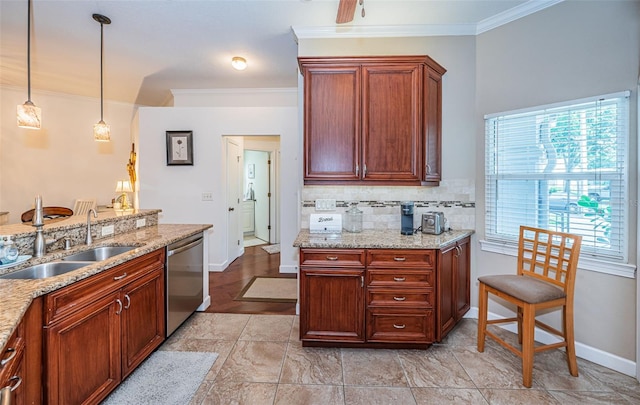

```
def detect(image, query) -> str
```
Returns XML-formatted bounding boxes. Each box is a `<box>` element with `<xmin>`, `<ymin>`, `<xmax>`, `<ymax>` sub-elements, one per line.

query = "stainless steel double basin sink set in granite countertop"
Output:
<box><xmin>0</xmin><ymin>246</ymin><xmax>137</xmax><ymax>279</ymax></box>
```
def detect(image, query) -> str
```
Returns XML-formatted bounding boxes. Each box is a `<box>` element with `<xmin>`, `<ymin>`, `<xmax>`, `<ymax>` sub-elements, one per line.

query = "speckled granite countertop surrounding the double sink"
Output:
<box><xmin>0</xmin><ymin>224</ymin><xmax>212</xmax><ymax>350</ymax></box>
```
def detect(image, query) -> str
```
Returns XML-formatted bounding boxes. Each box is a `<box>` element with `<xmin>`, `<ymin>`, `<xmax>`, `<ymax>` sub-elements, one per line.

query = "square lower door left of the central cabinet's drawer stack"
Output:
<box><xmin>300</xmin><ymin>268</ymin><xmax>365</xmax><ymax>342</ymax></box>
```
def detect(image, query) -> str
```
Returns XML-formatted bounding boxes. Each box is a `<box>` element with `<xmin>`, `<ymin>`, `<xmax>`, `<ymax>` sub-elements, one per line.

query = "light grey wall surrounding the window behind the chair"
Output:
<box><xmin>471</xmin><ymin>1</ymin><xmax>640</xmax><ymax>374</ymax></box>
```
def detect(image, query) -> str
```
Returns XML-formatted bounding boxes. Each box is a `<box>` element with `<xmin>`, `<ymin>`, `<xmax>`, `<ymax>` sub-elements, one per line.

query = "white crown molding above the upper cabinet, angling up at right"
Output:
<box><xmin>291</xmin><ymin>0</ymin><xmax>564</xmax><ymax>43</ymax></box>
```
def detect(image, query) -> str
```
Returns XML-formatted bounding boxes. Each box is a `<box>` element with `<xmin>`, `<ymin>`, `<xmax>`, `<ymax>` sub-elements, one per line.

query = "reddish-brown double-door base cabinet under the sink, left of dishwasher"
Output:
<box><xmin>44</xmin><ymin>249</ymin><xmax>165</xmax><ymax>404</ymax></box>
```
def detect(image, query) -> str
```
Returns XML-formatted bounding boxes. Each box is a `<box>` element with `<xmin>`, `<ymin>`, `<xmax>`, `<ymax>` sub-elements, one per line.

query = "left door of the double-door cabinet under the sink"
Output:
<box><xmin>45</xmin><ymin>292</ymin><xmax>123</xmax><ymax>404</ymax></box>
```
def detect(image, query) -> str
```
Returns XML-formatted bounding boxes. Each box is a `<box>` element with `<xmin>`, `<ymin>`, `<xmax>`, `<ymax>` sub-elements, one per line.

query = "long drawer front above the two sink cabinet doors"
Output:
<box><xmin>45</xmin><ymin>249</ymin><xmax>164</xmax><ymax>324</ymax></box>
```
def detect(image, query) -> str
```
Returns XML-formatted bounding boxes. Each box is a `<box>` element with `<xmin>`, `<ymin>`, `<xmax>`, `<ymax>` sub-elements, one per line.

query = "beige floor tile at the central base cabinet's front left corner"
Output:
<box><xmin>280</xmin><ymin>342</ymin><xmax>343</xmax><ymax>385</ymax></box>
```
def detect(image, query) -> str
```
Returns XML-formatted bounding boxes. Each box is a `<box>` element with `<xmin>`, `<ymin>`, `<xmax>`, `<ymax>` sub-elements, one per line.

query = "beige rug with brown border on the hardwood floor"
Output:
<box><xmin>235</xmin><ymin>276</ymin><xmax>298</xmax><ymax>302</ymax></box>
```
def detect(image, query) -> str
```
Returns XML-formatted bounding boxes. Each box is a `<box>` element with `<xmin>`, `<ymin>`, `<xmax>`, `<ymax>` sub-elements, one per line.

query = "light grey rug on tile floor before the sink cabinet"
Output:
<box><xmin>102</xmin><ymin>351</ymin><xmax>218</xmax><ymax>405</ymax></box>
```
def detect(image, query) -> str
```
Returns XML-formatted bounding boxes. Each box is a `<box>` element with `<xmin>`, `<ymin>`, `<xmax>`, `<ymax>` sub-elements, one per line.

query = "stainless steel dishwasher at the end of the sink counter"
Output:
<box><xmin>165</xmin><ymin>233</ymin><xmax>203</xmax><ymax>337</ymax></box>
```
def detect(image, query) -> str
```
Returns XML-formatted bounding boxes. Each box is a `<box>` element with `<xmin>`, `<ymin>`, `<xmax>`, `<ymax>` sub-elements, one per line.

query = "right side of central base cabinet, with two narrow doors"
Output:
<box><xmin>437</xmin><ymin>238</ymin><xmax>471</xmax><ymax>341</ymax></box>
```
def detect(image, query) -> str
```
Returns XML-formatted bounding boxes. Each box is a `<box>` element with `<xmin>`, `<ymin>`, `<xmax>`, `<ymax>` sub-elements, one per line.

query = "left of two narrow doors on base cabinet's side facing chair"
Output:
<box><xmin>436</xmin><ymin>245</ymin><xmax>457</xmax><ymax>341</ymax></box>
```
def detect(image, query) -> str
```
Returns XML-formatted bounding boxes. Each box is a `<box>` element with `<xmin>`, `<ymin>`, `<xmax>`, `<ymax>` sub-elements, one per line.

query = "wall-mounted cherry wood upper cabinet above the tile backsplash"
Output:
<box><xmin>299</xmin><ymin>56</ymin><xmax>446</xmax><ymax>185</ymax></box>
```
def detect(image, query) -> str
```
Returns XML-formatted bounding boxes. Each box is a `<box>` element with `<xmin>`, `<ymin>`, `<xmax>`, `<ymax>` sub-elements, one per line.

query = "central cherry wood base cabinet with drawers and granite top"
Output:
<box><xmin>294</xmin><ymin>230</ymin><xmax>473</xmax><ymax>348</ymax></box>
